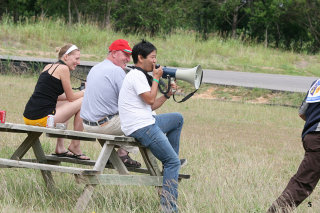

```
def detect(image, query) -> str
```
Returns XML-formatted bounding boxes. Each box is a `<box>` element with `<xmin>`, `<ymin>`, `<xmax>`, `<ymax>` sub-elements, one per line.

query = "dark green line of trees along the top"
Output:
<box><xmin>0</xmin><ymin>0</ymin><xmax>320</xmax><ymax>53</ymax></box>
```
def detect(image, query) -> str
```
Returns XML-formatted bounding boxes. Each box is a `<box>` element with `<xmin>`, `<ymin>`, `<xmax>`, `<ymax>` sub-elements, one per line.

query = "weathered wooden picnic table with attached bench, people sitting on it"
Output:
<box><xmin>0</xmin><ymin>123</ymin><xmax>190</xmax><ymax>211</ymax></box>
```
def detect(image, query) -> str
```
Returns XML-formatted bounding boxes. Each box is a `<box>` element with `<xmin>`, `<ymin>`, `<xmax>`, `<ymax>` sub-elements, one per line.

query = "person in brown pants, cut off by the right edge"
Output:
<box><xmin>268</xmin><ymin>79</ymin><xmax>320</xmax><ymax>213</ymax></box>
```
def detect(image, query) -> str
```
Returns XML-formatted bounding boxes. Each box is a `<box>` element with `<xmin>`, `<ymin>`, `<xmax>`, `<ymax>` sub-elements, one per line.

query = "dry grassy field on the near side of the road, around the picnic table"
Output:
<box><xmin>0</xmin><ymin>75</ymin><xmax>320</xmax><ymax>213</ymax></box>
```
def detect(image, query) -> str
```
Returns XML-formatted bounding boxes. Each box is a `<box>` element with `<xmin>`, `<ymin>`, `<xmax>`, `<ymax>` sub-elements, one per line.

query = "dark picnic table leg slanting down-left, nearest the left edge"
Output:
<box><xmin>11</xmin><ymin>132</ymin><xmax>42</xmax><ymax>160</ymax></box>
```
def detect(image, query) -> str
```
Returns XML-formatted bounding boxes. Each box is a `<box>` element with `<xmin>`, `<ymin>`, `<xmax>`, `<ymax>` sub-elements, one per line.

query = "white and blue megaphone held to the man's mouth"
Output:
<box><xmin>162</xmin><ymin>65</ymin><xmax>203</xmax><ymax>90</ymax></box>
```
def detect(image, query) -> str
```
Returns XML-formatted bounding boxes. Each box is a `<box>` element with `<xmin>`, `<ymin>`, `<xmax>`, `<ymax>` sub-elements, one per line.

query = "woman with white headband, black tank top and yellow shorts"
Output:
<box><xmin>23</xmin><ymin>44</ymin><xmax>90</xmax><ymax>160</ymax></box>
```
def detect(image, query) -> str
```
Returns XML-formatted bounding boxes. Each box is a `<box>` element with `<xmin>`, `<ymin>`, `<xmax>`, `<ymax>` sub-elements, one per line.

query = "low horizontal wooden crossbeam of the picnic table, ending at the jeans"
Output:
<box><xmin>77</xmin><ymin>174</ymin><xmax>163</xmax><ymax>186</ymax></box>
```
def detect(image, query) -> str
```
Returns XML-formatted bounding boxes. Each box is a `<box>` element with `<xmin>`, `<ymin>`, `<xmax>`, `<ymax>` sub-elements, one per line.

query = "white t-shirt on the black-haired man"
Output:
<box><xmin>118</xmin><ymin>69</ymin><xmax>155</xmax><ymax>135</ymax></box>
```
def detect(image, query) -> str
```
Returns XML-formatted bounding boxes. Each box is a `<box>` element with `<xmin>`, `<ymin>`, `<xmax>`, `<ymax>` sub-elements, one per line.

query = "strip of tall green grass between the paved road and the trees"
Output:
<box><xmin>0</xmin><ymin>17</ymin><xmax>320</xmax><ymax>76</ymax></box>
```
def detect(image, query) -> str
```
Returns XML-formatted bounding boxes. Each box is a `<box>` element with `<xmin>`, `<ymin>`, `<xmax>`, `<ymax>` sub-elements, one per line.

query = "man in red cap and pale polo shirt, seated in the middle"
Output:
<box><xmin>80</xmin><ymin>39</ymin><xmax>141</xmax><ymax>168</ymax></box>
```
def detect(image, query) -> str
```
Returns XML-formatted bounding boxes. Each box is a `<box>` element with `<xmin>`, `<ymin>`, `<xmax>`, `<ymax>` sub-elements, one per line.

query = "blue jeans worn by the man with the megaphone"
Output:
<box><xmin>130</xmin><ymin>113</ymin><xmax>183</xmax><ymax>212</ymax></box>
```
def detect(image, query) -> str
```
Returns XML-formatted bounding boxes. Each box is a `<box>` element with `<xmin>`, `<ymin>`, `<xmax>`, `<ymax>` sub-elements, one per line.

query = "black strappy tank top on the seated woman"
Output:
<box><xmin>23</xmin><ymin>64</ymin><xmax>64</xmax><ymax>120</ymax></box>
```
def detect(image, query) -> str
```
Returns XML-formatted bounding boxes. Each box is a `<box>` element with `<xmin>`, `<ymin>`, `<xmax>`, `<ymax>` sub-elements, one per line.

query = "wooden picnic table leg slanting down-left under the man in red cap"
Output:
<box><xmin>75</xmin><ymin>140</ymin><xmax>114</xmax><ymax>212</ymax></box>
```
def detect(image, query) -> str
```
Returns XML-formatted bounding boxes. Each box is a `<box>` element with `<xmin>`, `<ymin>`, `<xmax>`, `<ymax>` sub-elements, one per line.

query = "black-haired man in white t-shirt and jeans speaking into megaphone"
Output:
<box><xmin>118</xmin><ymin>40</ymin><xmax>185</xmax><ymax>212</ymax></box>
